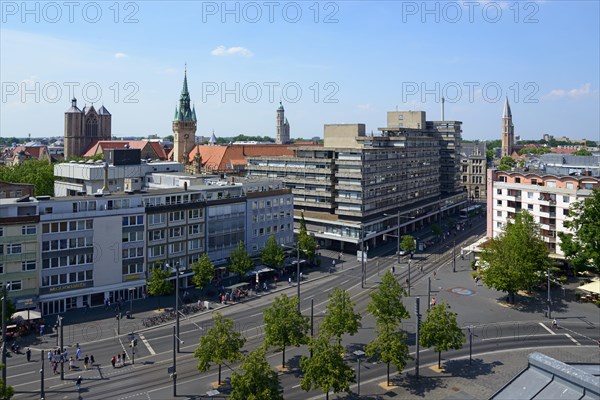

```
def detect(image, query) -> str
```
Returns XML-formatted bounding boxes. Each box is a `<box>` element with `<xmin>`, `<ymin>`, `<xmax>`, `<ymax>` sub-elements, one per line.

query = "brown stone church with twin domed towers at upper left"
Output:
<box><xmin>64</xmin><ymin>98</ymin><xmax>112</xmax><ymax>159</ymax></box>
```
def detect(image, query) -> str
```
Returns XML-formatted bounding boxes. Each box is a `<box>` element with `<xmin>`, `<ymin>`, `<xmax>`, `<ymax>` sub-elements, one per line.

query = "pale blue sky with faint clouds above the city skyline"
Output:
<box><xmin>0</xmin><ymin>1</ymin><xmax>600</xmax><ymax>140</ymax></box>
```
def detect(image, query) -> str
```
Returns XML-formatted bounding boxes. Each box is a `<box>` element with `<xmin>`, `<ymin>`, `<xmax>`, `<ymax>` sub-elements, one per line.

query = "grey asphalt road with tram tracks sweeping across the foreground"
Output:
<box><xmin>7</xmin><ymin>220</ymin><xmax>600</xmax><ymax>400</ymax></box>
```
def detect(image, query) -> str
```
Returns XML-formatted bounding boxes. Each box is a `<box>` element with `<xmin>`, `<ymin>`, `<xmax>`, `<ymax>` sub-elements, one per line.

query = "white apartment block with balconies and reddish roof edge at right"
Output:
<box><xmin>487</xmin><ymin>169</ymin><xmax>600</xmax><ymax>258</ymax></box>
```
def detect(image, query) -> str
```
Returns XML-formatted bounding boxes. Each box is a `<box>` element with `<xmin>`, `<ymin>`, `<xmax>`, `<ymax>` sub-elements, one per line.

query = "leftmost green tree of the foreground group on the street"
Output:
<box><xmin>194</xmin><ymin>312</ymin><xmax>246</xmax><ymax>385</ymax></box>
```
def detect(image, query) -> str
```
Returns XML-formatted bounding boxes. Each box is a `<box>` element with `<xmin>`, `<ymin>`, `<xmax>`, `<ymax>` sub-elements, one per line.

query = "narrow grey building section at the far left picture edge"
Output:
<box><xmin>0</xmin><ymin>198</ymin><xmax>40</xmax><ymax>310</ymax></box>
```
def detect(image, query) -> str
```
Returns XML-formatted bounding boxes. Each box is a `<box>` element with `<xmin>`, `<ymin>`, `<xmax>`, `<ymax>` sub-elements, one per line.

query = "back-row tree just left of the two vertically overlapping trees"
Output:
<box><xmin>321</xmin><ymin>288</ymin><xmax>362</xmax><ymax>344</ymax></box>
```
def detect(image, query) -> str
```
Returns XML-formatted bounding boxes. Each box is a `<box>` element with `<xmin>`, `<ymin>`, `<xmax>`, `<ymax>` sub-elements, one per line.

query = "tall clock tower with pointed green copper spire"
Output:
<box><xmin>173</xmin><ymin>69</ymin><xmax>196</xmax><ymax>164</ymax></box>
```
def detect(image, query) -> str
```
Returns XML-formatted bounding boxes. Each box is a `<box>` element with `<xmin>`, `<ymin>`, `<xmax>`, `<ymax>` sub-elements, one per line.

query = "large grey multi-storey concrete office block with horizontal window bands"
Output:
<box><xmin>247</xmin><ymin>112</ymin><xmax>466</xmax><ymax>251</ymax></box>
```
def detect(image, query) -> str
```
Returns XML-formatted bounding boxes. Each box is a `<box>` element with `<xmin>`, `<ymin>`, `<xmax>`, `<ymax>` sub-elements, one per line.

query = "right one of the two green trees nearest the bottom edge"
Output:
<box><xmin>300</xmin><ymin>335</ymin><xmax>354</xmax><ymax>399</ymax></box>
